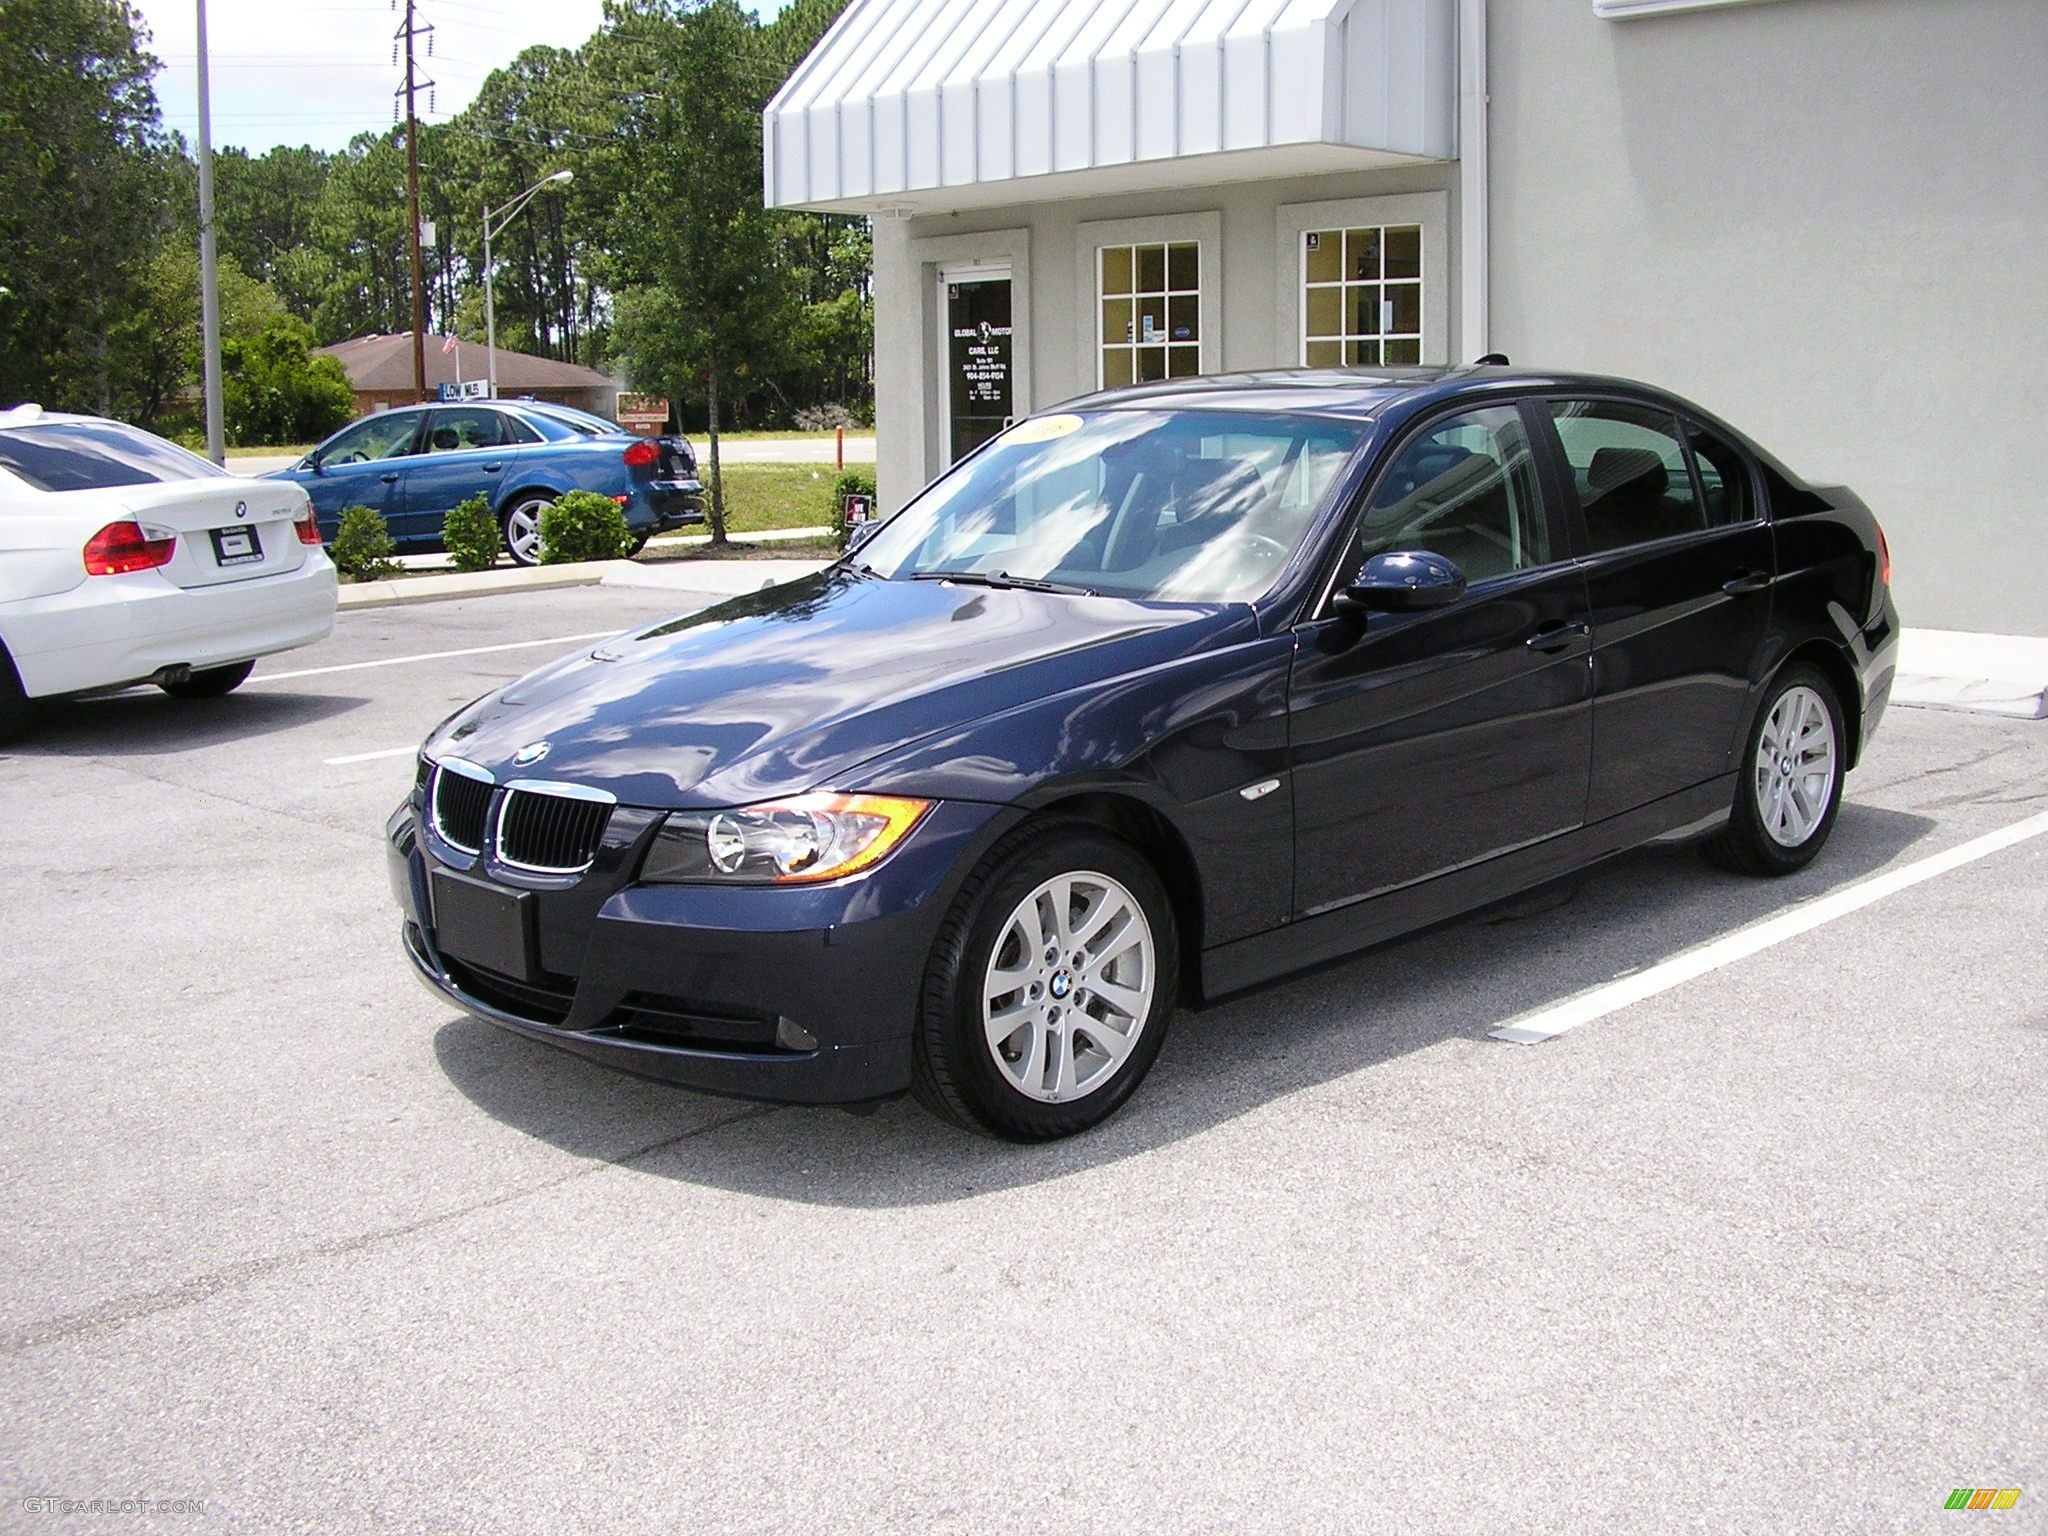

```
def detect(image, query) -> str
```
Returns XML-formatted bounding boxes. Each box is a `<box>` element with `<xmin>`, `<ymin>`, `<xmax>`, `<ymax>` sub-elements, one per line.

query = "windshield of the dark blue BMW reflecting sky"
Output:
<box><xmin>858</xmin><ymin>410</ymin><xmax>1364</xmax><ymax>602</ymax></box>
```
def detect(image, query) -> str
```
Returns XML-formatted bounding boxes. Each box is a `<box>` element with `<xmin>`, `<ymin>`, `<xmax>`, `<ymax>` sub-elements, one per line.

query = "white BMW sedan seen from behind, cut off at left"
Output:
<box><xmin>0</xmin><ymin>406</ymin><xmax>336</xmax><ymax>741</ymax></box>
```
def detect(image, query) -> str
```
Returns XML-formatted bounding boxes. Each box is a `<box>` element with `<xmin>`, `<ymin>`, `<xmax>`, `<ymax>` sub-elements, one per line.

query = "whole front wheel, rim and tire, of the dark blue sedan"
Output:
<box><xmin>915</xmin><ymin>823</ymin><xmax>1180</xmax><ymax>1141</ymax></box>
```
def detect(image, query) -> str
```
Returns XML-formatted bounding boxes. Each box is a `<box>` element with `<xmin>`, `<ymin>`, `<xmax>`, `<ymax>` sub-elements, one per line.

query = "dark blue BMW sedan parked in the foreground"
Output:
<box><xmin>387</xmin><ymin>367</ymin><xmax>1898</xmax><ymax>1141</ymax></box>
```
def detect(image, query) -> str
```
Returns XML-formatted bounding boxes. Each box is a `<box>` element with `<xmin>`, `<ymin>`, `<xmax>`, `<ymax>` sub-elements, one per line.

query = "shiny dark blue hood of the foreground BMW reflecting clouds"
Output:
<box><xmin>426</xmin><ymin>567</ymin><xmax>1251</xmax><ymax>809</ymax></box>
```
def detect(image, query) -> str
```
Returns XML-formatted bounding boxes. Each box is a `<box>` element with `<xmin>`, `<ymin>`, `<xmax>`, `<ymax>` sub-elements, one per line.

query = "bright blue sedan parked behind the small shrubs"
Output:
<box><xmin>274</xmin><ymin>399</ymin><xmax>705</xmax><ymax>565</ymax></box>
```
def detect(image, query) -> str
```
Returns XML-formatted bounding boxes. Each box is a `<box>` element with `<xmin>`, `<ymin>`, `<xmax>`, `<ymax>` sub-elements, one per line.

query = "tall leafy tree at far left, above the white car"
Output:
<box><xmin>0</xmin><ymin>0</ymin><xmax>170</xmax><ymax>414</ymax></box>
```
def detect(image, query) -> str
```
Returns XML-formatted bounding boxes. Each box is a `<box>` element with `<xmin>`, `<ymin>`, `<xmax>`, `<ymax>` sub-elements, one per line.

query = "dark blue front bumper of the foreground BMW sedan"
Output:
<box><xmin>385</xmin><ymin>801</ymin><xmax>1008</xmax><ymax>1104</ymax></box>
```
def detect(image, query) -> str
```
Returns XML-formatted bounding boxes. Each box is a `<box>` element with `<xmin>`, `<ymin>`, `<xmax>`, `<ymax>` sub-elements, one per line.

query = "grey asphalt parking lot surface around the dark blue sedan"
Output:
<box><xmin>0</xmin><ymin>588</ymin><xmax>2048</xmax><ymax>1532</ymax></box>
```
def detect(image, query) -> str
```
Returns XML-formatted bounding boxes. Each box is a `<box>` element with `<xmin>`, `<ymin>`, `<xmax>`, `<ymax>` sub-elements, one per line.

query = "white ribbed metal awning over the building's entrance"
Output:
<box><xmin>762</xmin><ymin>0</ymin><xmax>1458</xmax><ymax>213</ymax></box>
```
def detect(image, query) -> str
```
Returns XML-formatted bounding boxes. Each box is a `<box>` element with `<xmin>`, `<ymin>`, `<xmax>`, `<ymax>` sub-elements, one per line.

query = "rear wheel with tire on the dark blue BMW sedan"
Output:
<box><xmin>1706</xmin><ymin>666</ymin><xmax>1847</xmax><ymax>874</ymax></box>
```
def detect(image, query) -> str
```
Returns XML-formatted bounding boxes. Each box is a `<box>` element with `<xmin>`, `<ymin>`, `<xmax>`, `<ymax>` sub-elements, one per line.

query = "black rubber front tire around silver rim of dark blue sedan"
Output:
<box><xmin>911</xmin><ymin>819</ymin><xmax>1180</xmax><ymax>1143</ymax></box>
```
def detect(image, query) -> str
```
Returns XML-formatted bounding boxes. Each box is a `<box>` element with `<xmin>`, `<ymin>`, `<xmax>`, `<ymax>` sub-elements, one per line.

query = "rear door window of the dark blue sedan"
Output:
<box><xmin>1550</xmin><ymin>399</ymin><xmax>1706</xmax><ymax>555</ymax></box>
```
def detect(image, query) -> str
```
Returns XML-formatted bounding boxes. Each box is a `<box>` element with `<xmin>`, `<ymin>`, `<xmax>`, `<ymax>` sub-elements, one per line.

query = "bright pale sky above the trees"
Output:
<box><xmin>135</xmin><ymin>0</ymin><xmax>782</xmax><ymax>154</ymax></box>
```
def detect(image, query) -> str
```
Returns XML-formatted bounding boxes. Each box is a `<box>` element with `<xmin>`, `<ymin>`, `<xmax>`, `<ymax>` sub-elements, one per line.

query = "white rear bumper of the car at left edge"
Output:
<box><xmin>0</xmin><ymin>549</ymin><xmax>336</xmax><ymax>698</ymax></box>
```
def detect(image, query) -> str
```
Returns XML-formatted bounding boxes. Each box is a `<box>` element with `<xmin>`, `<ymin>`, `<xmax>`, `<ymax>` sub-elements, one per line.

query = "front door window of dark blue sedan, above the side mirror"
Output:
<box><xmin>1348</xmin><ymin>406</ymin><xmax>1550</xmax><ymax>582</ymax></box>
